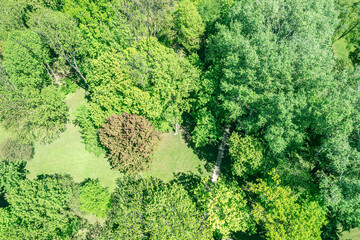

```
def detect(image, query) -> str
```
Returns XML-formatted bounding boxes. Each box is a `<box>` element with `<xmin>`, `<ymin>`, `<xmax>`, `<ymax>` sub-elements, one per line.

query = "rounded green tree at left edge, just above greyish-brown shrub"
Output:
<box><xmin>0</xmin><ymin>63</ymin><xmax>68</xmax><ymax>143</ymax></box>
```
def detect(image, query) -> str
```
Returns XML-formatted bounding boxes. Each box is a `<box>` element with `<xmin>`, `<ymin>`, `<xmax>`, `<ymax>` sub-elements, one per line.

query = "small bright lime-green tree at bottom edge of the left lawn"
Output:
<box><xmin>79</xmin><ymin>179</ymin><xmax>110</xmax><ymax>218</ymax></box>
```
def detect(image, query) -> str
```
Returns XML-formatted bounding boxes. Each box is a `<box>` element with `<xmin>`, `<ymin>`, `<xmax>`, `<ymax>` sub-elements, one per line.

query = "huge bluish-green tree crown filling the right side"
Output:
<box><xmin>194</xmin><ymin>0</ymin><xmax>359</xmax><ymax>236</ymax></box>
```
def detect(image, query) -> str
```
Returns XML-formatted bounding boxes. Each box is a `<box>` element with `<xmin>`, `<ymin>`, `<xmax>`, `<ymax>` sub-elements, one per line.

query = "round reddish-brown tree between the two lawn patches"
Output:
<box><xmin>99</xmin><ymin>113</ymin><xmax>160</xmax><ymax>174</ymax></box>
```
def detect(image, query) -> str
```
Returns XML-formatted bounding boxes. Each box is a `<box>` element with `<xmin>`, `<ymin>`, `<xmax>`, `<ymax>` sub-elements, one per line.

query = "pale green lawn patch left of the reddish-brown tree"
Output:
<box><xmin>27</xmin><ymin>90</ymin><xmax>120</xmax><ymax>190</ymax></box>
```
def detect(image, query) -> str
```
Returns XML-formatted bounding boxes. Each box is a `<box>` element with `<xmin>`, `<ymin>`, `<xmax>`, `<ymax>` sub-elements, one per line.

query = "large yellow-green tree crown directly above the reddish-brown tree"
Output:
<box><xmin>89</xmin><ymin>38</ymin><xmax>199</xmax><ymax>131</ymax></box>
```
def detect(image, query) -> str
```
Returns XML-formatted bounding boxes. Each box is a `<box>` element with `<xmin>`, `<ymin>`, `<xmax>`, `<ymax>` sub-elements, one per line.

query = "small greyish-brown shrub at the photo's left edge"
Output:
<box><xmin>0</xmin><ymin>138</ymin><xmax>34</xmax><ymax>161</ymax></box>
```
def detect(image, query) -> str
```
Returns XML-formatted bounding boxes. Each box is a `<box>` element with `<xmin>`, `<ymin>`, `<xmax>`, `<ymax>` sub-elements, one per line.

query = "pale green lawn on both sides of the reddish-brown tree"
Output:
<box><xmin>26</xmin><ymin>89</ymin><xmax>205</xmax><ymax>191</ymax></box>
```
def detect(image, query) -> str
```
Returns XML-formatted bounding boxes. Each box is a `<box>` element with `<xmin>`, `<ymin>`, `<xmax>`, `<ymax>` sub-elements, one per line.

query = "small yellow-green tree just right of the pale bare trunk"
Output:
<box><xmin>228</xmin><ymin>132</ymin><xmax>263</xmax><ymax>177</ymax></box>
